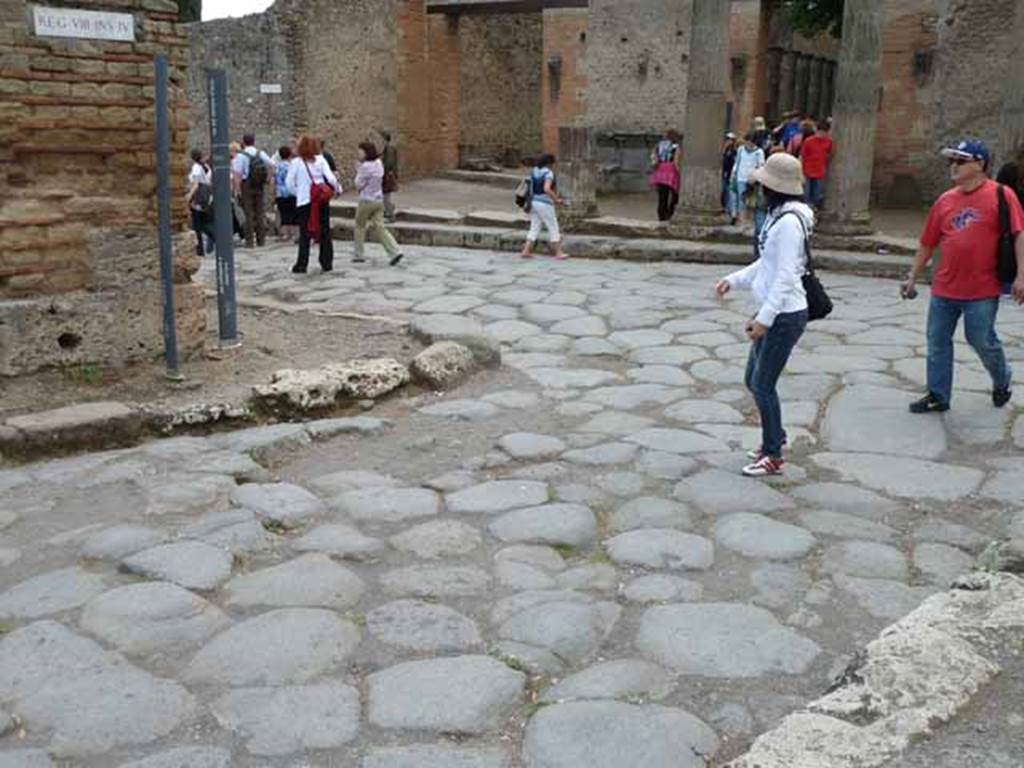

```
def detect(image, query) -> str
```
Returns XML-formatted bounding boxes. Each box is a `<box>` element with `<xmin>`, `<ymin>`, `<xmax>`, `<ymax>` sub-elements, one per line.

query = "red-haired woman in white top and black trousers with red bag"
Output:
<box><xmin>286</xmin><ymin>136</ymin><xmax>341</xmax><ymax>274</ymax></box>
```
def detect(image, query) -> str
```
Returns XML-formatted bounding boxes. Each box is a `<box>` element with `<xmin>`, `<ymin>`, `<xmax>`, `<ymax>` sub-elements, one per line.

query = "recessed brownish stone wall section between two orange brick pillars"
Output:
<box><xmin>459</xmin><ymin>13</ymin><xmax>544</xmax><ymax>164</ymax></box>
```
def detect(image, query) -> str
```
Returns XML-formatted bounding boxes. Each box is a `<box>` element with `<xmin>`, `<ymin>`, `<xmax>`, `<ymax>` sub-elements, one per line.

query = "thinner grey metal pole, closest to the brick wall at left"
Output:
<box><xmin>154</xmin><ymin>55</ymin><xmax>182</xmax><ymax>380</ymax></box>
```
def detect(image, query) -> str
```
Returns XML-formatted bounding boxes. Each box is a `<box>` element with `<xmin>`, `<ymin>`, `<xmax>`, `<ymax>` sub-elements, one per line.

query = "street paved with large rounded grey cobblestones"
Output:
<box><xmin>0</xmin><ymin>244</ymin><xmax>1024</xmax><ymax>768</ymax></box>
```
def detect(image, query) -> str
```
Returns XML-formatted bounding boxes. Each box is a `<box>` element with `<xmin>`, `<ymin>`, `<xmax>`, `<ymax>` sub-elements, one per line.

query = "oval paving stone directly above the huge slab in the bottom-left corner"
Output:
<box><xmin>81</xmin><ymin>582</ymin><xmax>231</xmax><ymax>655</ymax></box>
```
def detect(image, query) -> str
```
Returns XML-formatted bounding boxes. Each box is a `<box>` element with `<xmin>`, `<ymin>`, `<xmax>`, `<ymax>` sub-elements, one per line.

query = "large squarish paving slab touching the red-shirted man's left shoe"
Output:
<box><xmin>821</xmin><ymin>385</ymin><xmax>946</xmax><ymax>459</ymax></box>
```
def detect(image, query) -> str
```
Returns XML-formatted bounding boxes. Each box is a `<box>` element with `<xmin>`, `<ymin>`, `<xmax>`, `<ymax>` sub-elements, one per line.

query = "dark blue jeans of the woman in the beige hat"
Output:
<box><xmin>743</xmin><ymin>309</ymin><xmax>807</xmax><ymax>459</ymax></box>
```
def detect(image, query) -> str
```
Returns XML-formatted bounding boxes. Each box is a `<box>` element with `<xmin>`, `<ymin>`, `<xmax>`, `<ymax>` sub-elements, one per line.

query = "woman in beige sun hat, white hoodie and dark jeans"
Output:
<box><xmin>715</xmin><ymin>153</ymin><xmax>814</xmax><ymax>477</ymax></box>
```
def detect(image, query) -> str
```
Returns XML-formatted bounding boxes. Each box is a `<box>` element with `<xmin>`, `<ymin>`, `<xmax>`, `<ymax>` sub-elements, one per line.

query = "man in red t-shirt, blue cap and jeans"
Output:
<box><xmin>902</xmin><ymin>140</ymin><xmax>1024</xmax><ymax>414</ymax></box>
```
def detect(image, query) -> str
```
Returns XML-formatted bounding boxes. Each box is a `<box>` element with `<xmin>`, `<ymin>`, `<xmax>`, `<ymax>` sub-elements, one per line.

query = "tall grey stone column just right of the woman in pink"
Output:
<box><xmin>676</xmin><ymin>0</ymin><xmax>730</xmax><ymax>226</ymax></box>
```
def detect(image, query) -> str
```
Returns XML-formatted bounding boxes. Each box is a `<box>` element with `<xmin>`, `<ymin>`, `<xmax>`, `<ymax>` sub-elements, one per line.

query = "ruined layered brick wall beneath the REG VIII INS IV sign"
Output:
<box><xmin>0</xmin><ymin>0</ymin><xmax>205</xmax><ymax>376</ymax></box>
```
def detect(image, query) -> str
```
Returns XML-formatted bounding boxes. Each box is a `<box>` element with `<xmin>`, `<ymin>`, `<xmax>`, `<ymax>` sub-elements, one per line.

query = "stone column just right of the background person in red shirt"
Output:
<box><xmin>821</xmin><ymin>0</ymin><xmax>883</xmax><ymax>234</ymax></box>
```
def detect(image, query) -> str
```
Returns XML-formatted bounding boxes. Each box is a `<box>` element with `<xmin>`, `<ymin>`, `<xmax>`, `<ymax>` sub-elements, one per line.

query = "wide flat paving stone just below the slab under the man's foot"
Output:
<box><xmin>811</xmin><ymin>454</ymin><xmax>985</xmax><ymax>502</ymax></box>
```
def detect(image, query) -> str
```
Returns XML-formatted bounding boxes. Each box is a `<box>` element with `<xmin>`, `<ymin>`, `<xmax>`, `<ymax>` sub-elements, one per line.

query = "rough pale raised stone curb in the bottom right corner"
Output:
<box><xmin>727</xmin><ymin>572</ymin><xmax>1024</xmax><ymax>768</ymax></box>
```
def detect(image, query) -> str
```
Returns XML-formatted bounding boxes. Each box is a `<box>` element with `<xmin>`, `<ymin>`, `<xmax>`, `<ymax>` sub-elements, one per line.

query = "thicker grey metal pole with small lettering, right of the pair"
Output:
<box><xmin>206</xmin><ymin>70</ymin><xmax>242</xmax><ymax>347</ymax></box>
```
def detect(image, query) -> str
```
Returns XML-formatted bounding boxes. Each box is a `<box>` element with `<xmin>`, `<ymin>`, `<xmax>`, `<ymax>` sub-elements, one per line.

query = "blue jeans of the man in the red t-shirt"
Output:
<box><xmin>928</xmin><ymin>296</ymin><xmax>1012</xmax><ymax>404</ymax></box>
